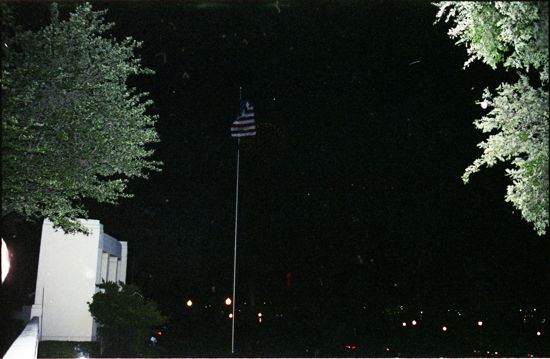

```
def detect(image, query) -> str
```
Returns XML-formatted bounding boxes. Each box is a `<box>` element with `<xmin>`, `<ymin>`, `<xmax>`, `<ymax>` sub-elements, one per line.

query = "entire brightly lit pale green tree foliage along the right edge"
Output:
<box><xmin>435</xmin><ymin>1</ymin><xmax>549</xmax><ymax>235</ymax></box>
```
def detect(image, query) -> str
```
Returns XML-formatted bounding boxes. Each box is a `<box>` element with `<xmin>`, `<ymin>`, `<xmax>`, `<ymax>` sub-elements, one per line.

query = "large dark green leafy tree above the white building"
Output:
<box><xmin>2</xmin><ymin>3</ymin><xmax>161</xmax><ymax>231</ymax></box>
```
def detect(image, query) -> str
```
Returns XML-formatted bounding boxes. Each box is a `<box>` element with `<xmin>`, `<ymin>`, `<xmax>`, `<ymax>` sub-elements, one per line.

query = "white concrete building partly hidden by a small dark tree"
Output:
<box><xmin>31</xmin><ymin>220</ymin><xmax>128</xmax><ymax>341</ymax></box>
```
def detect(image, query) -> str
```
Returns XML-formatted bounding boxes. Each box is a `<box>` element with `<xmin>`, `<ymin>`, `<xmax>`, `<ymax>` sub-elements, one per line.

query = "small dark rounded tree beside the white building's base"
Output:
<box><xmin>88</xmin><ymin>282</ymin><xmax>166</xmax><ymax>355</ymax></box>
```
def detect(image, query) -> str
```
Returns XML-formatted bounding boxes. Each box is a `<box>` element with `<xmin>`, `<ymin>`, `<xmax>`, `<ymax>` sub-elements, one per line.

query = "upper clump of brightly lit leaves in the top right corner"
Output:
<box><xmin>434</xmin><ymin>1</ymin><xmax>548</xmax><ymax>83</ymax></box>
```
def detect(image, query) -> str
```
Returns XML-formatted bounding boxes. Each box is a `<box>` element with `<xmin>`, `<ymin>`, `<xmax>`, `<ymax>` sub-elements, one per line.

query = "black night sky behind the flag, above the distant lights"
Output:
<box><xmin>5</xmin><ymin>1</ymin><xmax>550</xmax><ymax>334</ymax></box>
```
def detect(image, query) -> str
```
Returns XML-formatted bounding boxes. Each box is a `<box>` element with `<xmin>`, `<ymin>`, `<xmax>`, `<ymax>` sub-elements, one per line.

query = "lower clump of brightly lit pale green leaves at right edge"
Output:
<box><xmin>462</xmin><ymin>76</ymin><xmax>549</xmax><ymax>235</ymax></box>
